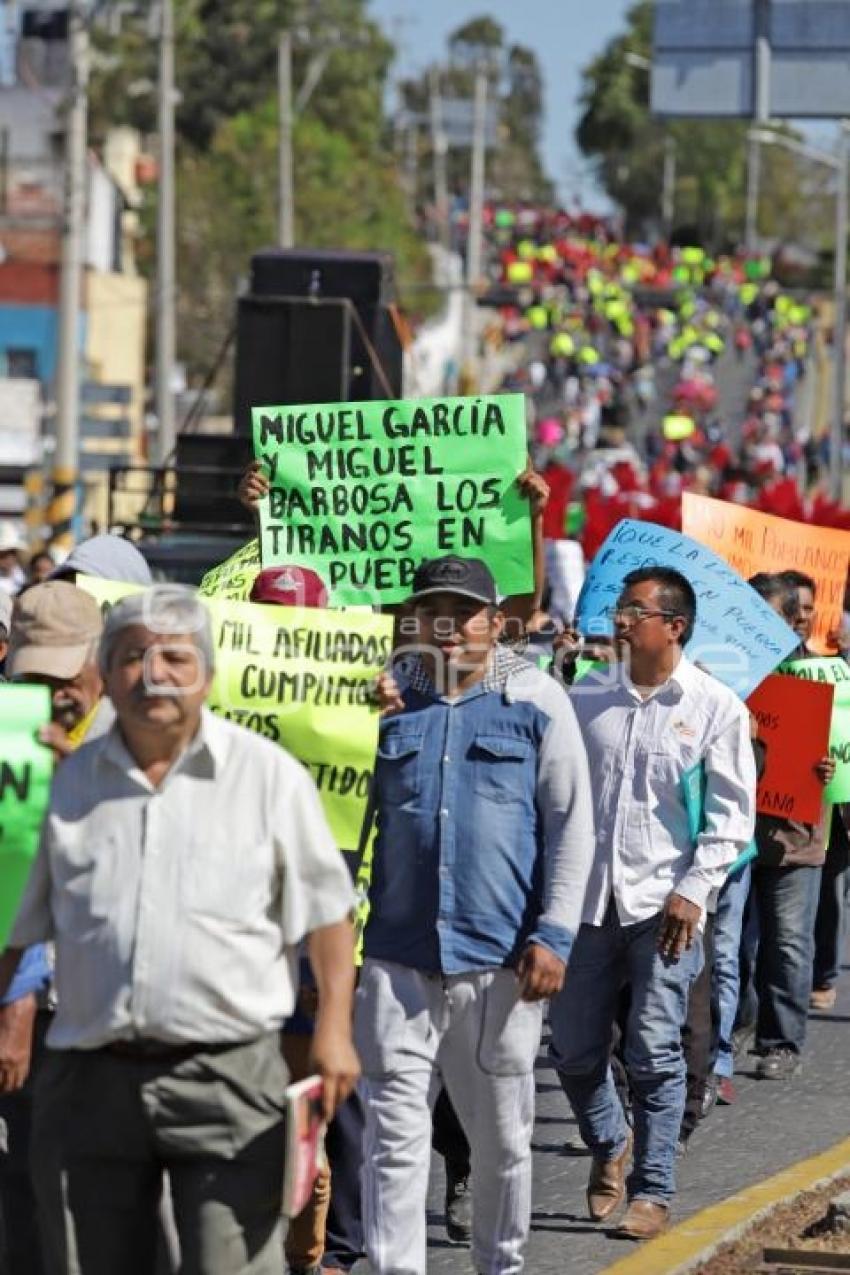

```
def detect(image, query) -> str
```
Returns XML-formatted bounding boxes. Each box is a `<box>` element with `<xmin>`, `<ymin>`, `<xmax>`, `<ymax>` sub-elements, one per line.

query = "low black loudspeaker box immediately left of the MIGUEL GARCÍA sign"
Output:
<box><xmin>175</xmin><ymin>434</ymin><xmax>254</xmax><ymax>530</ymax></box>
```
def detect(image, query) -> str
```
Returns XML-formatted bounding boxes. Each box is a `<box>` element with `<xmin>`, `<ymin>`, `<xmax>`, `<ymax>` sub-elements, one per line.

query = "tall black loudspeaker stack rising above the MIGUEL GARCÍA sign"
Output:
<box><xmin>233</xmin><ymin>250</ymin><xmax>404</xmax><ymax>437</ymax></box>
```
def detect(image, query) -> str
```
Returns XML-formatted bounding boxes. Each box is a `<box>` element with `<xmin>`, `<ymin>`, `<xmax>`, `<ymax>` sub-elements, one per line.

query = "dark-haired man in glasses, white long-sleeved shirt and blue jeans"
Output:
<box><xmin>549</xmin><ymin>567</ymin><xmax>756</xmax><ymax>1239</ymax></box>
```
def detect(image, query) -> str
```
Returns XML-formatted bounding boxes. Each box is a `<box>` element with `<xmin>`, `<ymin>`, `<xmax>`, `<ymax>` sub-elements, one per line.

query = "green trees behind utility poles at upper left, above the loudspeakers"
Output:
<box><xmin>90</xmin><ymin>0</ymin><xmax>429</xmax><ymax>374</ymax></box>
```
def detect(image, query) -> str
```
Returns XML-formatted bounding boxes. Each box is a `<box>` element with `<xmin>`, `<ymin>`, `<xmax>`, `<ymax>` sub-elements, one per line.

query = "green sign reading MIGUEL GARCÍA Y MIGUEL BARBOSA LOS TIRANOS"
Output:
<box><xmin>252</xmin><ymin>394</ymin><xmax>533</xmax><ymax>606</ymax></box>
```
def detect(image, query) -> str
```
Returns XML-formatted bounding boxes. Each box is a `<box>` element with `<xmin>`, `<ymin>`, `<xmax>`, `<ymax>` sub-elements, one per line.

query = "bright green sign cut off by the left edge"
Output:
<box><xmin>0</xmin><ymin>682</ymin><xmax>54</xmax><ymax>947</ymax></box>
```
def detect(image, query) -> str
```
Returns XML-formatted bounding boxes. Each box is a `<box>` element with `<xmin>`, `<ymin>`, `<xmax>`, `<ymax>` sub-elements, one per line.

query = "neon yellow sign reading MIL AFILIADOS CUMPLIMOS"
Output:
<box><xmin>78</xmin><ymin>576</ymin><xmax>393</xmax><ymax>853</ymax></box>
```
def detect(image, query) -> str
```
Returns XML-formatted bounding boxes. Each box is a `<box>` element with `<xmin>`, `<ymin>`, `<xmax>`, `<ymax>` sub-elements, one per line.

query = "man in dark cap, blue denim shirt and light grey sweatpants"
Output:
<box><xmin>354</xmin><ymin>556</ymin><xmax>593</xmax><ymax>1275</ymax></box>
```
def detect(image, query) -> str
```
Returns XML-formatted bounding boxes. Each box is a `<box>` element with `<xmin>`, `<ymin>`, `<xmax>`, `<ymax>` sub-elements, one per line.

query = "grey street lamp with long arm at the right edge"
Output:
<box><xmin>748</xmin><ymin>120</ymin><xmax>850</xmax><ymax>501</ymax></box>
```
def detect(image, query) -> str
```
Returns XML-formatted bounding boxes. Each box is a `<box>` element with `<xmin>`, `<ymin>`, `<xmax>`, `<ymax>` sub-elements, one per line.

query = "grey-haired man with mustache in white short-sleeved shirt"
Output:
<box><xmin>0</xmin><ymin>585</ymin><xmax>359</xmax><ymax>1275</ymax></box>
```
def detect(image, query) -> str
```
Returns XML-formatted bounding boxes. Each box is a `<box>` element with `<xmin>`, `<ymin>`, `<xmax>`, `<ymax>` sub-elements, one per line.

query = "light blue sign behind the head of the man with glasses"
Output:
<box><xmin>576</xmin><ymin>518</ymin><xmax>799</xmax><ymax>700</ymax></box>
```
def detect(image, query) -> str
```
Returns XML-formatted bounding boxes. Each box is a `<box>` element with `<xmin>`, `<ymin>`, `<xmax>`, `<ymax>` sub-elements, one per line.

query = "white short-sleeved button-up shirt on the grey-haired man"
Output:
<box><xmin>10</xmin><ymin>709</ymin><xmax>354</xmax><ymax>1049</ymax></box>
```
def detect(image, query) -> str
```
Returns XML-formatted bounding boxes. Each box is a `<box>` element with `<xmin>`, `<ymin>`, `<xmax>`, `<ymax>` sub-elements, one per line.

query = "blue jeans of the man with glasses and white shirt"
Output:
<box><xmin>549</xmin><ymin>903</ymin><xmax>702</xmax><ymax>1204</ymax></box>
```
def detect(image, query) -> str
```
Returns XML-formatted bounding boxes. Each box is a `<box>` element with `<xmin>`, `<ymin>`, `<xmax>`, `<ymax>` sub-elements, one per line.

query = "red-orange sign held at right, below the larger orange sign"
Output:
<box><xmin>747</xmin><ymin>673</ymin><xmax>835</xmax><ymax>824</ymax></box>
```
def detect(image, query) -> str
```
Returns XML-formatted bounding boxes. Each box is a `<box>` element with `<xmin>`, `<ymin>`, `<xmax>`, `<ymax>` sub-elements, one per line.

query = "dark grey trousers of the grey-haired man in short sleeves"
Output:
<box><xmin>32</xmin><ymin>1034</ymin><xmax>287</xmax><ymax>1275</ymax></box>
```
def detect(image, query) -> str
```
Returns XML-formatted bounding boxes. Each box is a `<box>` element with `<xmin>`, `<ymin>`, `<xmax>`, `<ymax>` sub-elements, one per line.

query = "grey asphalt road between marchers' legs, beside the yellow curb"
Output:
<box><xmin>356</xmin><ymin>974</ymin><xmax>850</xmax><ymax>1275</ymax></box>
